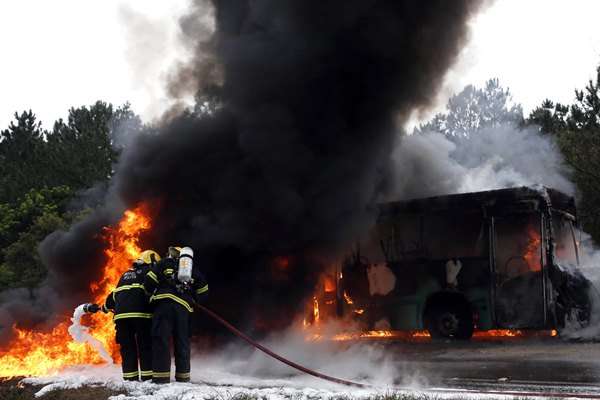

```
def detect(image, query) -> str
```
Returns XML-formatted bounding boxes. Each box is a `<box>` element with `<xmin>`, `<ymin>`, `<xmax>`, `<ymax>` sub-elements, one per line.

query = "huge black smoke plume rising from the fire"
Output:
<box><xmin>1</xmin><ymin>0</ymin><xmax>480</xmax><ymax>338</ymax></box>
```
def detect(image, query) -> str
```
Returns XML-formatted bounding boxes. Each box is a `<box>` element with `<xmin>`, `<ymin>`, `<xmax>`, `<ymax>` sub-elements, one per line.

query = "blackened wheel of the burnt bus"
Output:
<box><xmin>425</xmin><ymin>300</ymin><xmax>473</xmax><ymax>340</ymax></box>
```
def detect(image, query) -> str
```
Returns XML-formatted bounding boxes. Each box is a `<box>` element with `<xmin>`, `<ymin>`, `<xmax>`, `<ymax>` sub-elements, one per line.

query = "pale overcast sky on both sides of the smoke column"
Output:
<box><xmin>0</xmin><ymin>0</ymin><xmax>600</xmax><ymax>129</ymax></box>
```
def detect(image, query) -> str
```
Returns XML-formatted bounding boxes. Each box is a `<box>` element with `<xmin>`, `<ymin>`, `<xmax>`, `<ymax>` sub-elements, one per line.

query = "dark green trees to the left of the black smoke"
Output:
<box><xmin>0</xmin><ymin>101</ymin><xmax>143</xmax><ymax>291</ymax></box>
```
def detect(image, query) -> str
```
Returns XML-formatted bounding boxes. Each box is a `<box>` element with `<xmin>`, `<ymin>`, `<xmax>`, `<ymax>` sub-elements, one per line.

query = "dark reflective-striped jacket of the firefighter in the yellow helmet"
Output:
<box><xmin>102</xmin><ymin>264</ymin><xmax>152</xmax><ymax>321</ymax></box>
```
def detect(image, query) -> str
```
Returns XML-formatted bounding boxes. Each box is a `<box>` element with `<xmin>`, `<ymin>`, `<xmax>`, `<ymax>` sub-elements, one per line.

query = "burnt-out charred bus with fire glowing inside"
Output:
<box><xmin>336</xmin><ymin>187</ymin><xmax>591</xmax><ymax>339</ymax></box>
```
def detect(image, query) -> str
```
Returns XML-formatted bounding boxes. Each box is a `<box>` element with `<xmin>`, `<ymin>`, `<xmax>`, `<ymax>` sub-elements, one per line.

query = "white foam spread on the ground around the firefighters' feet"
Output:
<box><xmin>24</xmin><ymin>365</ymin><xmax>514</xmax><ymax>400</ymax></box>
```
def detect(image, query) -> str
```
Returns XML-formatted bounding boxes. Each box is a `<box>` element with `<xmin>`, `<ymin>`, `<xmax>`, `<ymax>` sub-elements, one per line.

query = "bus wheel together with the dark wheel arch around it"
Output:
<box><xmin>423</xmin><ymin>291</ymin><xmax>474</xmax><ymax>340</ymax></box>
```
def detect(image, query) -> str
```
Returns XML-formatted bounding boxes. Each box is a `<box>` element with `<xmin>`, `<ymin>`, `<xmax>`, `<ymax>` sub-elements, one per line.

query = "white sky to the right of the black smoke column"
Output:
<box><xmin>438</xmin><ymin>0</ymin><xmax>600</xmax><ymax>119</ymax></box>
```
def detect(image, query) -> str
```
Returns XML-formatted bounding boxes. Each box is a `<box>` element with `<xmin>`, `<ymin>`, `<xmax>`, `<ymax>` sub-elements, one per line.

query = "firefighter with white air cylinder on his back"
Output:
<box><xmin>144</xmin><ymin>247</ymin><xmax>208</xmax><ymax>383</ymax></box>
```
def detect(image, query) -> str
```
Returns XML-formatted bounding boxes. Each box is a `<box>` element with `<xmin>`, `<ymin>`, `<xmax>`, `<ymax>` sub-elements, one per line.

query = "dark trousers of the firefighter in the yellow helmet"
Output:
<box><xmin>115</xmin><ymin>318</ymin><xmax>152</xmax><ymax>381</ymax></box>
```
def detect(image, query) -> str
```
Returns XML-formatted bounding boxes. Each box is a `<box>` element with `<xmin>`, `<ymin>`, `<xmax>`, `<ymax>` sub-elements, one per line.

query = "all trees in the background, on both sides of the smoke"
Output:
<box><xmin>0</xmin><ymin>66</ymin><xmax>600</xmax><ymax>291</ymax></box>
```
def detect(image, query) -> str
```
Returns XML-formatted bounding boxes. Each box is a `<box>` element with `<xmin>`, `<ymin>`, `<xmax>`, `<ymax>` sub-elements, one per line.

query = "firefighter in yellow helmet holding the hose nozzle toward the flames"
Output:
<box><xmin>86</xmin><ymin>250</ymin><xmax>160</xmax><ymax>381</ymax></box>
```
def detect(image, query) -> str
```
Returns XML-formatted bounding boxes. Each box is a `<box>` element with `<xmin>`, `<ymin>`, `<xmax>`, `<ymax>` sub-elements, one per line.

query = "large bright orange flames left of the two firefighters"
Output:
<box><xmin>0</xmin><ymin>204</ymin><xmax>151</xmax><ymax>377</ymax></box>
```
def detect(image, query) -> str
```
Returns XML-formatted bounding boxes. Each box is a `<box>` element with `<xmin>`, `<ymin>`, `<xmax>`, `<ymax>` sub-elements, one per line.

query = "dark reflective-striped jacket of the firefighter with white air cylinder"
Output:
<box><xmin>144</xmin><ymin>258</ymin><xmax>208</xmax><ymax>312</ymax></box>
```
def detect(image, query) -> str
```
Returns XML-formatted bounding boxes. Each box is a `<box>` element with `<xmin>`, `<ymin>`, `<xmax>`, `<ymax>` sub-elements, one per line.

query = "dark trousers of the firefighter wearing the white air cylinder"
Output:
<box><xmin>152</xmin><ymin>299</ymin><xmax>190</xmax><ymax>383</ymax></box>
